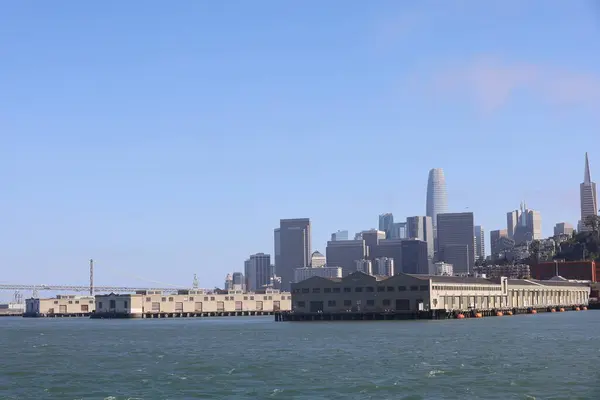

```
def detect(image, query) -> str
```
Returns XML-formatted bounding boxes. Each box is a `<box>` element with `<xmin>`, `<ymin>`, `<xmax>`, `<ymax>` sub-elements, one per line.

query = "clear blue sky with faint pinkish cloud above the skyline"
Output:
<box><xmin>0</xmin><ymin>0</ymin><xmax>600</xmax><ymax>287</ymax></box>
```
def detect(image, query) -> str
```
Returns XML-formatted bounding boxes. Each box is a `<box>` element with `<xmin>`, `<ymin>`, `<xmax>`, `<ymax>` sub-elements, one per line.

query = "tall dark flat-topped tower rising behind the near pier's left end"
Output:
<box><xmin>277</xmin><ymin>218</ymin><xmax>311</xmax><ymax>291</ymax></box>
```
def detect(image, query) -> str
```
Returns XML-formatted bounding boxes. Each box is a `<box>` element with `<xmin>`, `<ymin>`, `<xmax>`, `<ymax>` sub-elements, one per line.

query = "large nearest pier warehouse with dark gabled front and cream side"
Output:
<box><xmin>292</xmin><ymin>272</ymin><xmax>590</xmax><ymax>314</ymax></box>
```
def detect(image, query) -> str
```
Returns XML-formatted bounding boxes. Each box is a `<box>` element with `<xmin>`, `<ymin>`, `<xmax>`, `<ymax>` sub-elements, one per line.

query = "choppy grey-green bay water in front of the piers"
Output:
<box><xmin>0</xmin><ymin>311</ymin><xmax>600</xmax><ymax>400</ymax></box>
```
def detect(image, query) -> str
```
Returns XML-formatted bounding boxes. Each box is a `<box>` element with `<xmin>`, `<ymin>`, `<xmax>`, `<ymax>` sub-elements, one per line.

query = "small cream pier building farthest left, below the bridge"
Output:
<box><xmin>24</xmin><ymin>295</ymin><xmax>95</xmax><ymax>317</ymax></box>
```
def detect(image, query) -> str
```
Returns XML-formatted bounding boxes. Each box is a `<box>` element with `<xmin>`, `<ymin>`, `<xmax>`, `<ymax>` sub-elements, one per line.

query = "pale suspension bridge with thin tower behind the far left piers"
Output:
<box><xmin>0</xmin><ymin>260</ymin><xmax>211</xmax><ymax>297</ymax></box>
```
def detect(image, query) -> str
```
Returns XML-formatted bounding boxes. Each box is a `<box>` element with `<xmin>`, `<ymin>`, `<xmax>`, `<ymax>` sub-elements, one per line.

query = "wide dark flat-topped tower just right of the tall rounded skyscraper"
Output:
<box><xmin>437</xmin><ymin>212</ymin><xmax>475</xmax><ymax>274</ymax></box>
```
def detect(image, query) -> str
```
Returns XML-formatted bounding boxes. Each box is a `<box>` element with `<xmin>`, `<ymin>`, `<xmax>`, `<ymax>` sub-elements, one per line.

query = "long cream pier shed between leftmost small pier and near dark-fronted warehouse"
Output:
<box><xmin>92</xmin><ymin>289</ymin><xmax>291</xmax><ymax>318</ymax></box>
